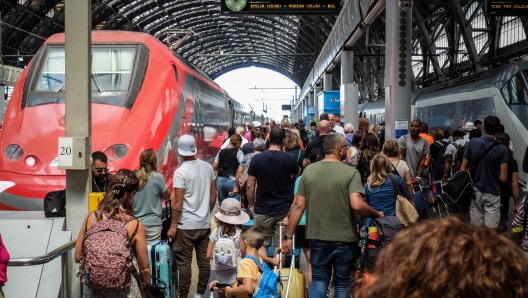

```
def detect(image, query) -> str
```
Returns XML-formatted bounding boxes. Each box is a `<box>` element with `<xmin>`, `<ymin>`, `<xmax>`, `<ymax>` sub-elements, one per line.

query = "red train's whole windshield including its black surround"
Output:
<box><xmin>23</xmin><ymin>44</ymin><xmax>148</xmax><ymax>108</ymax></box>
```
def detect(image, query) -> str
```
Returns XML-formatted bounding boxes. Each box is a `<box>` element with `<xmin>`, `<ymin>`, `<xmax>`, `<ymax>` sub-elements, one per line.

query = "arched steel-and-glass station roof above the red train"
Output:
<box><xmin>0</xmin><ymin>0</ymin><xmax>344</xmax><ymax>85</ymax></box>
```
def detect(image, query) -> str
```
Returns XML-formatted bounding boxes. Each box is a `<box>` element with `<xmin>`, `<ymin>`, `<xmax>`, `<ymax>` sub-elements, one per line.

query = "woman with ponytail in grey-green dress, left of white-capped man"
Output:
<box><xmin>132</xmin><ymin>148</ymin><xmax>170</xmax><ymax>244</ymax></box>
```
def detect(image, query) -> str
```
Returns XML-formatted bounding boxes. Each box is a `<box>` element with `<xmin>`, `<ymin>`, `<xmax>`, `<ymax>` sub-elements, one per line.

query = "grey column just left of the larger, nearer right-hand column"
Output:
<box><xmin>339</xmin><ymin>49</ymin><xmax>358</xmax><ymax>129</ymax></box>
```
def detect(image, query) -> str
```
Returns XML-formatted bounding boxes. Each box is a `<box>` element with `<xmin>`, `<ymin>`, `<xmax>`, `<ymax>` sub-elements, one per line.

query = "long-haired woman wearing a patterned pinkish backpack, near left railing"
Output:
<box><xmin>75</xmin><ymin>169</ymin><xmax>151</xmax><ymax>298</ymax></box>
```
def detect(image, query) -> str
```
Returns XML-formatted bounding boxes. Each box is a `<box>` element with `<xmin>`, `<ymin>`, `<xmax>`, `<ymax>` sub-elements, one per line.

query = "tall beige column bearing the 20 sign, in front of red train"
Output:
<box><xmin>64</xmin><ymin>0</ymin><xmax>92</xmax><ymax>298</ymax></box>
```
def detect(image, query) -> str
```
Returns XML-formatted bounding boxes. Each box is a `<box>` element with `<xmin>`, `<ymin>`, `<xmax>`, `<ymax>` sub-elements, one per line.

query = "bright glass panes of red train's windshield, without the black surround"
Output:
<box><xmin>35</xmin><ymin>47</ymin><xmax>136</xmax><ymax>92</ymax></box>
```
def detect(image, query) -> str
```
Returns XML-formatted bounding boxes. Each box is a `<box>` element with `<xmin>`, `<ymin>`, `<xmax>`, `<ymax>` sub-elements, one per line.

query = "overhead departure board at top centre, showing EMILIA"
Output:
<box><xmin>221</xmin><ymin>0</ymin><xmax>339</xmax><ymax>14</ymax></box>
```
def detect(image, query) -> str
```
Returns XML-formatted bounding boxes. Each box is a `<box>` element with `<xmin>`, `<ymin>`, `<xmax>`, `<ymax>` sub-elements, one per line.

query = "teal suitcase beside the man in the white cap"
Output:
<box><xmin>147</xmin><ymin>240</ymin><xmax>178</xmax><ymax>298</ymax></box>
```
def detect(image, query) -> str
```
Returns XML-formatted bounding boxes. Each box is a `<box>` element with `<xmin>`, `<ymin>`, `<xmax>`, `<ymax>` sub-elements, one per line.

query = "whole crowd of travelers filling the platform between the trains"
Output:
<box><xmin>0</xmin><ymin>114</ymin><xmax>528</xmax><ymax>298</ymax></box>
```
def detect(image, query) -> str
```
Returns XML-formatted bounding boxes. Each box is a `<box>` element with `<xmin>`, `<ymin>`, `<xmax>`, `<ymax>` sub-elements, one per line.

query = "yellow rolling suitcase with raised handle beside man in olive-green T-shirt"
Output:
<box><xmin>274</xmin><ymin>225</ymin><xmax>306</xmax><ymax>298</ymax></box>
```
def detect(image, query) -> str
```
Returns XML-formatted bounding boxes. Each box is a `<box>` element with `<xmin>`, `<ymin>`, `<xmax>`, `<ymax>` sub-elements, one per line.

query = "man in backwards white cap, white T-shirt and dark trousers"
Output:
<box><xmin>167</xmin><ymin>135</ymin><xmax>216</xmax><ymax>298</ymax></box>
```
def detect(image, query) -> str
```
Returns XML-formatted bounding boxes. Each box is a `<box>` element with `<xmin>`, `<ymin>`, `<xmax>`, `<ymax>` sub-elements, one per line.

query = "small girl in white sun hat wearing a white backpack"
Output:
<box><xmin>207</xmin><ymin>198</ymin><xmax>249</xmax><ymax>297</ymax></box>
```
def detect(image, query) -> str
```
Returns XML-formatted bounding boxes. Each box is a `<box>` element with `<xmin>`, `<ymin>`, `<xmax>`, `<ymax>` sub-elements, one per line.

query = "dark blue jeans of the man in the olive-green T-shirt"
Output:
<box><xmin>310</xmin><ymin>240</ymin><xmax>358</xmax><ymax>298</ymax></box>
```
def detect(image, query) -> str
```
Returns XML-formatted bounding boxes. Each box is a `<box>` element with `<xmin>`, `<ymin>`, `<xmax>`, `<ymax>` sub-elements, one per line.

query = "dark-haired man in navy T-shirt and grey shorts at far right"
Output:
<box><xmin>460</xmin><ymin>116</ymin><xmax>508</xmax><ymax>229</ymax></box>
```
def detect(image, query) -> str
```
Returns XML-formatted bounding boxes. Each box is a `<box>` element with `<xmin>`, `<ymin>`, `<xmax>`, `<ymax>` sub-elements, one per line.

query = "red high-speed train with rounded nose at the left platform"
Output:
<box><xmin>0</xmin><ymin>31</ymin><xmax>265</xmax><ymax>210</ymax></box>
